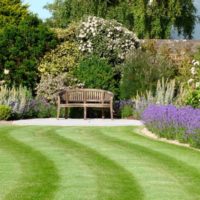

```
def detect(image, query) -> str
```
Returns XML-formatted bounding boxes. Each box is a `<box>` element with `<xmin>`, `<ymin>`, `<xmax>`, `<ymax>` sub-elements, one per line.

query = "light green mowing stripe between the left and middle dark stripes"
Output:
<box><xmin>13</xmin><ymin>127</ymin><xmax>102</xmax><ymax>200</ymax></box>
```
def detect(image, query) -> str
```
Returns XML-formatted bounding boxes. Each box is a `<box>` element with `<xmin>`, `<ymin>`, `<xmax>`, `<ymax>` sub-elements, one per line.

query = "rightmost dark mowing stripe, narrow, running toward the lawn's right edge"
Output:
<box><xmin>98</xmin><ymin>128</ymin><xmax>200</xmax><ymax>199</ymax></box>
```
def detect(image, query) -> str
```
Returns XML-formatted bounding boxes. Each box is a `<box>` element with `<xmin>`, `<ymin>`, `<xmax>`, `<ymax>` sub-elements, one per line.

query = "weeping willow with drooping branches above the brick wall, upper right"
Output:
<box><xmin>132</xmin><ymin>0</ymin><xmax>196</xmax><ymax>39</ymax></box>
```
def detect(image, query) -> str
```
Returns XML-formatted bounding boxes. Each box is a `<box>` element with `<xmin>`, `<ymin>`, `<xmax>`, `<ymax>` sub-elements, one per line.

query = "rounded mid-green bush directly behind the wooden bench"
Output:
<box><xmin>74</xmin><ymin>56</ymin><xmax>116</xmax><ymax>92</ymax></box>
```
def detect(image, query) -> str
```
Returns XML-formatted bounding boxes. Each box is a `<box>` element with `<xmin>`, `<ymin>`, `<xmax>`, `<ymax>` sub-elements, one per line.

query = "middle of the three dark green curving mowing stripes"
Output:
<box><xmin>43</xmin><ymin>129</ymin><xmax>143</xmax><ymax>200</ymax></box>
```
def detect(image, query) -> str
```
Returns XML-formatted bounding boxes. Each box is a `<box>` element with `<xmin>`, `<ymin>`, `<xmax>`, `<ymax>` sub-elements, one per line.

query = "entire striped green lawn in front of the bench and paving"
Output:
<box><xmin>0</xmin><ymin>126</ymin><xmax>200</xmax><ymax>200</ymax></box>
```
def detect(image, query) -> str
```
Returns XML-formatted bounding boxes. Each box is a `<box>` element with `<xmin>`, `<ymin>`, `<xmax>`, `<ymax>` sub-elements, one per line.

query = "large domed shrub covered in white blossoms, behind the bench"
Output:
<box><xmin>77</xmin><ymin>16</ymin><xmax>139</xmax><ymax>64</ymax></box>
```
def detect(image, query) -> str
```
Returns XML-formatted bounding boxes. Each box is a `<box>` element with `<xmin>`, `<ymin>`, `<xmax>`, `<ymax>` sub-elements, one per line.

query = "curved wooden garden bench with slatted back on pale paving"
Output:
<box><xmin>57</xmin><ymin>89</ymin><xmax>114</xmax><ymax>119</ymax></box>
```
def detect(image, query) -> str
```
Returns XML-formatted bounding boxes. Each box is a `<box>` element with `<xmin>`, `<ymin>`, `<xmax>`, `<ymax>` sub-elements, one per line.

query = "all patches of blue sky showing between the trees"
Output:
<box><xmin>23</xmin><ymin>0</ymin><xmax>200</xmax><ymax>39</ymax></box>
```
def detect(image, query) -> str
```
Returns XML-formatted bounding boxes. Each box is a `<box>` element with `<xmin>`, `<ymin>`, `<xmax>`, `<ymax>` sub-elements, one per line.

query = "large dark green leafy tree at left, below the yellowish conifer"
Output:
<box><xmin>0</xmin><ymin>16</ymin><xmax>57</xmax><ymax>89</ymax></box>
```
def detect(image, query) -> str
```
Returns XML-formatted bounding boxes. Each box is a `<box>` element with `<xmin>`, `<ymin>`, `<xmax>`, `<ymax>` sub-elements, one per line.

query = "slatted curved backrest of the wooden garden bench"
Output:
<box><xmin>59</xmin><ymin>89</ymin><xmax>114</xmax><ymax>103</ymax></box>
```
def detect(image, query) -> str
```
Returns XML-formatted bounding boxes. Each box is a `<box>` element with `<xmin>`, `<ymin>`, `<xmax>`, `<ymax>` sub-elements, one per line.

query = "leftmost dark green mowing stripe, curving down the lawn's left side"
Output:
<box><xmin>0</xmin><ymin>127</ymin><xmax>59</xmax><ymax>200</ymax></box>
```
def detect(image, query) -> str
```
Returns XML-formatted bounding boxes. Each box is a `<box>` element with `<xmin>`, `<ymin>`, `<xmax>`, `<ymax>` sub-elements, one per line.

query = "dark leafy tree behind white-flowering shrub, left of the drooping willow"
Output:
<box><xmin>46</xmin><ymin>0</ymin><xmax>133</xmax><ymax>28</ymax></box>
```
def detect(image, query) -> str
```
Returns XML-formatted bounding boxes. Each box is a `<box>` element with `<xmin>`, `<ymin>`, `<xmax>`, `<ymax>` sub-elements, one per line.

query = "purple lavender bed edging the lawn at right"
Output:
<box><xmin>142</xmin><ymin>105</ymin><xmax>200</xmax><ymax>148</ymax></box>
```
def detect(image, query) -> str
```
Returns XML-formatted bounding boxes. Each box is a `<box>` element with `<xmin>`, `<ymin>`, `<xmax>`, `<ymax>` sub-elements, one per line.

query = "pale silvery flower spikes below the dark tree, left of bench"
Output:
<box><xmin>0</xmin><ymin>86</ymin><xmax>32</xmax><ymax>118</ymax></box>
